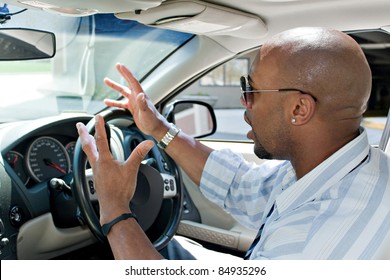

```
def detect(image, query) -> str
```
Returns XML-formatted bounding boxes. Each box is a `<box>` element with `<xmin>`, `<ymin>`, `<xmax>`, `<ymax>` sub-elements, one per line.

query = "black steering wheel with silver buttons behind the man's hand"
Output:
<box><xmin>72</xmin><ymin>109</ymin><xmax>183</xmax><ymax>250</ymax></box>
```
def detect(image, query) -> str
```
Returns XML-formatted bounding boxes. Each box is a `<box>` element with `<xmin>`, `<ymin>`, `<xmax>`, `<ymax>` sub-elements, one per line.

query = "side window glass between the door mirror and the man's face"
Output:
<box><xmin>177</xmin><ymin>52</ymin><xmax>256</xmax><ymax>141</ymax></box>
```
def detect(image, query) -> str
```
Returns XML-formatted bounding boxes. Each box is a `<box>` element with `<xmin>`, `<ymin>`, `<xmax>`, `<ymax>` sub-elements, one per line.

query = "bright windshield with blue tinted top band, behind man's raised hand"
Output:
<box><xmin>0</xmin><ymin>6</ymin><xmax>192</xmax><ymax>122</ymax></box>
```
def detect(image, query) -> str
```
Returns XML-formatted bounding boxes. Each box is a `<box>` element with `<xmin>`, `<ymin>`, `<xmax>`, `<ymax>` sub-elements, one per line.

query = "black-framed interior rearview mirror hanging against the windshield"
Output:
<box><xmin>0</xmin><ymin>28</ymin><xmax>56</xmax><ymax>61</ymax></box>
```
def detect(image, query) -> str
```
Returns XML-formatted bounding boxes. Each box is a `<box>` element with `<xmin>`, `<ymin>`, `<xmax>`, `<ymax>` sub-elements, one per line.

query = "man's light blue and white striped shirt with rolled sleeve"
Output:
<box><xmin>200</xmin><ymin>129</ymin><xmax>390</xmax><ymax>259</ymax></box>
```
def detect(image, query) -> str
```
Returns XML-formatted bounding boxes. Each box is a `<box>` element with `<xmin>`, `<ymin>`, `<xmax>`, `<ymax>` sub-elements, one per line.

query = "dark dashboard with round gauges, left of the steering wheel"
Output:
<box><xmin>0</xmin><ymin>115</ymin><xmax>92</xmax><ymax>259</ymax></box>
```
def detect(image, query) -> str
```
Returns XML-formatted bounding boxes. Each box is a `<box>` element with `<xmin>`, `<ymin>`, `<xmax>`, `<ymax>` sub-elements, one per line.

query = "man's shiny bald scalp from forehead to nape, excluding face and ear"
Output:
<box><xmin>253</xmin><ymin>28</ymin><xmax>371</xmax><ymax>122</ymax></box>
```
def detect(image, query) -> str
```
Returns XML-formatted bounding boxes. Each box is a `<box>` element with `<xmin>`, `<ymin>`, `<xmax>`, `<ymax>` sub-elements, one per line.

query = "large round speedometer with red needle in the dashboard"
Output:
<box><xmin>26</xmin><ymin>136</ymin><xmax>70</xmax><ymax>182</ymax></box>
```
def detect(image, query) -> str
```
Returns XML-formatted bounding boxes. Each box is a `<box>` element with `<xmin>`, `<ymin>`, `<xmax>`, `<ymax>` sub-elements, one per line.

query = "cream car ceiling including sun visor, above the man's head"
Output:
<box><xmin>7</xmin><ymin>0</ymin><xmax>390</xmax><ymax>40</ymax></box>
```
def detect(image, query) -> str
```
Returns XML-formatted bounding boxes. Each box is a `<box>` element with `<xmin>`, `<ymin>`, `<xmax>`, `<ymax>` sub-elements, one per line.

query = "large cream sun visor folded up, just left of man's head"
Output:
<box><xmin>116</xmin><ymin>1</ymin><xmax>267</xmax><ymax>39</ymax></box>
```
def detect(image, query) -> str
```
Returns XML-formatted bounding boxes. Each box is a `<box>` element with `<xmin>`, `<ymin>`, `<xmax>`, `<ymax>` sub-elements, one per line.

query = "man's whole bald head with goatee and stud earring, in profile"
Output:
<box><xmin>246</xmin><ymin>28</ymin><xmax>371</xmax><ymax>175</ymax></box>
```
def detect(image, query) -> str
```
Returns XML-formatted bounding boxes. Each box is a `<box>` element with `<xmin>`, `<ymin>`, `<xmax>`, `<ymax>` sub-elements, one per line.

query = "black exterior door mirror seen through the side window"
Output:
<box><xmin>165</xmin><ymin>100</ymin><xmax>217</xmax><ymax>138</ymax></box>
